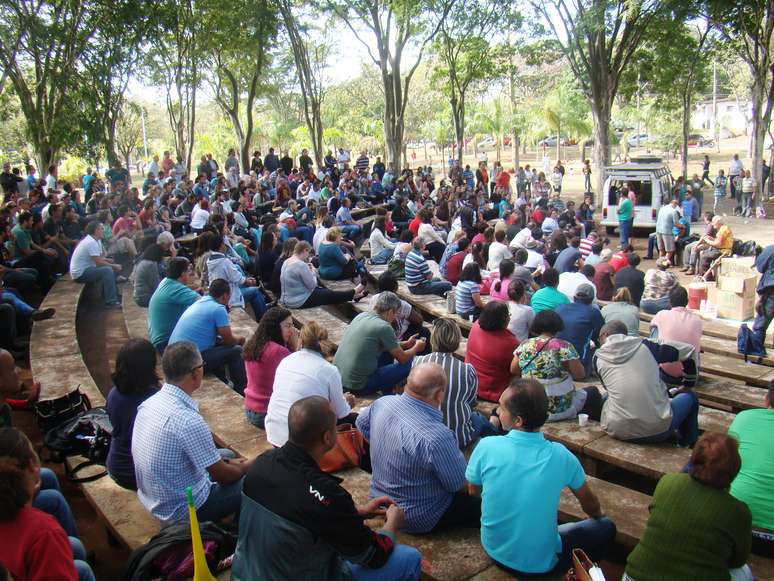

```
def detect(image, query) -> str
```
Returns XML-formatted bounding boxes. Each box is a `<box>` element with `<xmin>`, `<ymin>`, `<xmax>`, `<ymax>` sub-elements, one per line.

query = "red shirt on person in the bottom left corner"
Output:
<box><xmin>0</xmin><ymin>506</ymin><xmax>78</xmax><ymax>581</ymax></box>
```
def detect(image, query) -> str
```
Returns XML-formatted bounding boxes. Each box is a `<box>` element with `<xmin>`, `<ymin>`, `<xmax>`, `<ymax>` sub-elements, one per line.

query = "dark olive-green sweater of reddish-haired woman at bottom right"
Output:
<box><xmin>626</xmin><ymin>474</ymin><xmax>752</xmax><ymax>581</ymax></box>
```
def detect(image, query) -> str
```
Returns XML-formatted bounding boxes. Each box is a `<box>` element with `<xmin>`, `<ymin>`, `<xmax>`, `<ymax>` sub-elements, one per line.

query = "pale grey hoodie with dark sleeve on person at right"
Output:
<box><xmin>595</xmin><ymin>335</ymin><xmax>694</xmax><ymax>440</ymax></box>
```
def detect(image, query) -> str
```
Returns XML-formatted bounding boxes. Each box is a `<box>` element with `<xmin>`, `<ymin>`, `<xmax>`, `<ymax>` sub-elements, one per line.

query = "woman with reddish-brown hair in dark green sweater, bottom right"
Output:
<box><xmin>623</xmin><ymin>432</ymin><xmax>753</xmax><ymax>581</ymax></box>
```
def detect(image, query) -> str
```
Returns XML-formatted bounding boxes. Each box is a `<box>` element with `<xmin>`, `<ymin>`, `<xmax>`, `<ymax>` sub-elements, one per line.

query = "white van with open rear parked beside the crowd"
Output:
<box><xmin>601</xmin><ymin>156</ymin><xmax>674</xmax><ymax>234</ymax></box>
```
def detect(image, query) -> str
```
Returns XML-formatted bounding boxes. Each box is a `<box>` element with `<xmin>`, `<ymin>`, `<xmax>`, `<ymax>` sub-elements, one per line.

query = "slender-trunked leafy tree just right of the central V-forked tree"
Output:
<box><xmin>433</xmin><ymin>0</ymin><xmax>520</xmax><ymax>163</ymax></box>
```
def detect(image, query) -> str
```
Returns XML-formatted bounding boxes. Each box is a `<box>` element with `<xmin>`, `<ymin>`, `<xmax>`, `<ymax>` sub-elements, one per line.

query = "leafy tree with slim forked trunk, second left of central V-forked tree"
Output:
<box><xmin>199</xmin><ymin>0</ymin><xmax>277</xmax><ymax>171</ymax></box>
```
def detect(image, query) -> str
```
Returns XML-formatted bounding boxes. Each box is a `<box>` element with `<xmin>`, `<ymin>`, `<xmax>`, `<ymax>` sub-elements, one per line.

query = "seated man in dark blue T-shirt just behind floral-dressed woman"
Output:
<box><xmin>555</xmin><ymin>284</ymin><xmax>605</xmax><ymax>374</ymax></box>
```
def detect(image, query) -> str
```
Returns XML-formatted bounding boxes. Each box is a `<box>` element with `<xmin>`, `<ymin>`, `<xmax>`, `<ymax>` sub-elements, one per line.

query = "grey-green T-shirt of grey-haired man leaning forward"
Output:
<box><xmin>333</xmin><ymin>313</ymin><xmax>398</xmax><ymax>391</ymax></box>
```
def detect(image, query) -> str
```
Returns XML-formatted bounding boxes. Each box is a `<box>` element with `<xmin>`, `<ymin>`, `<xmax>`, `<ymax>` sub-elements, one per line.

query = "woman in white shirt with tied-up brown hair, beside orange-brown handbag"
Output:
<box><xmin>265</xmin><ymin>321</ymin><xmax>356</xmax><ymax>447</ymax></box>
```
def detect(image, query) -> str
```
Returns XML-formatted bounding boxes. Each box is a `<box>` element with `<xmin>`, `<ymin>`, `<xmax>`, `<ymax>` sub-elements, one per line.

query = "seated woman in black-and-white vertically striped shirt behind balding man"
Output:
<box><xmin>413</xmin><ymin>317</ymin><xmax>497</xmax><ymax>450</ymax></box>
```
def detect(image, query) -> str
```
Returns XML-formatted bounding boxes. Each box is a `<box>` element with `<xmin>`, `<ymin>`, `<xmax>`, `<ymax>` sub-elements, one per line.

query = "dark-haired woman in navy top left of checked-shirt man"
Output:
<box><xmin>105</xmin><ymin>339</ymin><xmax>160</xmax><ymax>490</ymax></box>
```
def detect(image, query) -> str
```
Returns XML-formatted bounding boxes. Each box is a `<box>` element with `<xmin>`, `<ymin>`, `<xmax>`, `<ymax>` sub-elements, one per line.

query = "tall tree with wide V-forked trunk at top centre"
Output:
<box><xmin>325</xmin><ymin>0</ymin><xmax>454</xmax><ymax>173</ymax></box>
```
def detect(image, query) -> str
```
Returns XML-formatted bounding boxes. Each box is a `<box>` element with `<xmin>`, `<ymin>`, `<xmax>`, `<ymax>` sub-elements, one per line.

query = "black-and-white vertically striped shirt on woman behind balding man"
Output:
<box><xmin>412</xmin><ymin>348</ymin><xmax>478</xmax><ymax>448</ymax></box>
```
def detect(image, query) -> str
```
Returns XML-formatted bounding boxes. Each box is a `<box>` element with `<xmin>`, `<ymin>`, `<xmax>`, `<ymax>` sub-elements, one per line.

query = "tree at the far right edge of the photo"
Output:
<box><xmin>710</xmin><ymin>0</ymin><xmax>774</xmax><ymax>191</ymax></box>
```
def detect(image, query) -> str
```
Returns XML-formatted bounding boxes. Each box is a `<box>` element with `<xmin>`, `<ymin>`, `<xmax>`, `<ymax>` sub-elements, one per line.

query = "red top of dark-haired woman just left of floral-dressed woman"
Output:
<box><xmin>465</xmin><ymin>321</ymin><xmax>519</xmax><ymax>401</ymax></box>
